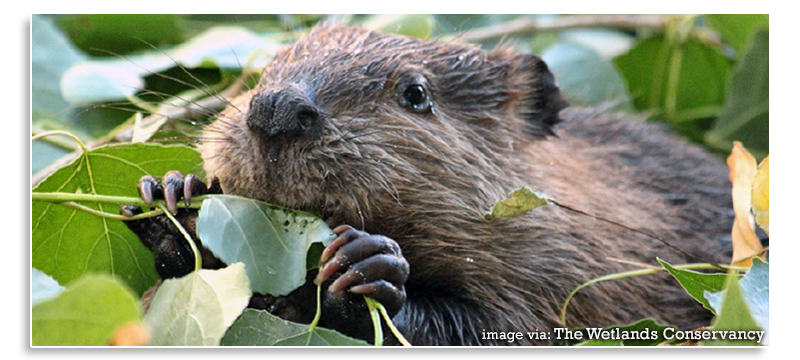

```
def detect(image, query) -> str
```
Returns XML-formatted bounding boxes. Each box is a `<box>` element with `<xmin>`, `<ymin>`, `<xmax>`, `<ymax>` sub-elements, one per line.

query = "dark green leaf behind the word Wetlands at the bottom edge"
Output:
<box><xmin>560</xmin><ymin>319</ymin><xmax>675</xmax><ymax>346</ymax></box>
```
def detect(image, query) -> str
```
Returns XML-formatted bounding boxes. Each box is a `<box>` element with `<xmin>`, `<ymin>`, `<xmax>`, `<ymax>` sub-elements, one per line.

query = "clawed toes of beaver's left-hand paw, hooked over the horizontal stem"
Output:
<box><xmin>137</xmin><ymin>171</ymin><xmax>208</xmax><ymax>215</ymax></box>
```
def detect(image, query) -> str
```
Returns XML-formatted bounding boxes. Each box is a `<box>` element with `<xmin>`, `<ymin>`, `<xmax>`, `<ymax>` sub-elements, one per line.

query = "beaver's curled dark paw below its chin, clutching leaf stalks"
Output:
<box><xmin>314</xmin><ymin>225</ymin><xmax>409</xmax><ymax>313</ymax></box>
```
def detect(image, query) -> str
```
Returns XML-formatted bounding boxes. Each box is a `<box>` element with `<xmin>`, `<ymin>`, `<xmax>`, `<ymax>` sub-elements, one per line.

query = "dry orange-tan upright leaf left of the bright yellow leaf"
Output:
<box><xmin>728</xmin><ymin>141</ymin><xmax>764</xmax><ymax>267</ymax></box>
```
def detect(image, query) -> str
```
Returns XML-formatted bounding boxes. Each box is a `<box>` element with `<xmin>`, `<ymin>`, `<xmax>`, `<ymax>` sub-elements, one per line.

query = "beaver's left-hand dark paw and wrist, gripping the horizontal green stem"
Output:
<box><xmin>120</xmin><ymin>171</ymin><xmax>220</xmax><ymax>279</ymax></box>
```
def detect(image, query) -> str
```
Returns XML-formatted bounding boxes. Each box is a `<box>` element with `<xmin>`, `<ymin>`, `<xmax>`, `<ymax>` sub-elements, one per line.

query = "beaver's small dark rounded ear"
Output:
<box><xmin>519</xmin><ymin>55</ymin><xmax>568</xmax><ymax>138</ymax></box>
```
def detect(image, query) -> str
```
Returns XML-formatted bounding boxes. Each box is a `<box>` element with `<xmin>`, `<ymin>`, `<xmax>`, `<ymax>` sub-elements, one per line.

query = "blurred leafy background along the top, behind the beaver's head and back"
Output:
<box><xmin>31</xmin><ymin>15</ymin><xmax>769</xmax><ymax>181</ymax></box>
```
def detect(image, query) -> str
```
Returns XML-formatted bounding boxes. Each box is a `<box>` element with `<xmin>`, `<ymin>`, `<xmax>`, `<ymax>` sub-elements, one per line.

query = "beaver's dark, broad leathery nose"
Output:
<box><xmin>247</xmin><ymin>87</ymin><xmax>321</xmax><ymax>137</ymax></box>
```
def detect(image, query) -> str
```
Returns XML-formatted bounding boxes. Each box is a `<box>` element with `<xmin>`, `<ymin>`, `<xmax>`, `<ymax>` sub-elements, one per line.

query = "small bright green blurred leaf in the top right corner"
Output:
<box><xmin>703</xmin><ymin>14</ymin><xmax>769</xmax><ymax>53</ymax></box>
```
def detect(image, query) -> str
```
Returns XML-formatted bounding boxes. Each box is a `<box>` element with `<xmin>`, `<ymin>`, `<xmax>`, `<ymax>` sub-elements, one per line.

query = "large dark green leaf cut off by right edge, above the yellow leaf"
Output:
<box><xmin>706</xmin><ymin>29</ymin><xmax>769</xmax><ymax>158</ymax></box>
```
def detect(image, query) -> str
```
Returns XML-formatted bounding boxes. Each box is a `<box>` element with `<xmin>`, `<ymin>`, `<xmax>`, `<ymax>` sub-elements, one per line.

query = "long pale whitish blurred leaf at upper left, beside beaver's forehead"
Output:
<box><xmin>61</xmin><ymin>27</ymin><xmax>279</xmax><ymax>104</ymax></box>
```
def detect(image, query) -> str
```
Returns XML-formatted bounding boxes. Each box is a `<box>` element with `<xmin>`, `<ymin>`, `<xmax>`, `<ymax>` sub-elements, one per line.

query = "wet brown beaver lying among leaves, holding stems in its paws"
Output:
<box><xmin>123</xmin><ymin>24</ymin><xmax>731</xmax><ymax>345</ymax></box>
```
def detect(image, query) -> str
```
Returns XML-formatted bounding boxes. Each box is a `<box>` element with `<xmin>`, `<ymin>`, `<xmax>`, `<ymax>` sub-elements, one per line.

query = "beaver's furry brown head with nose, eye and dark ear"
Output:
<box><xmin>201</xmin><ymin>25</ymin><xmax>565</xmax><ymax>226</ymax></box>
